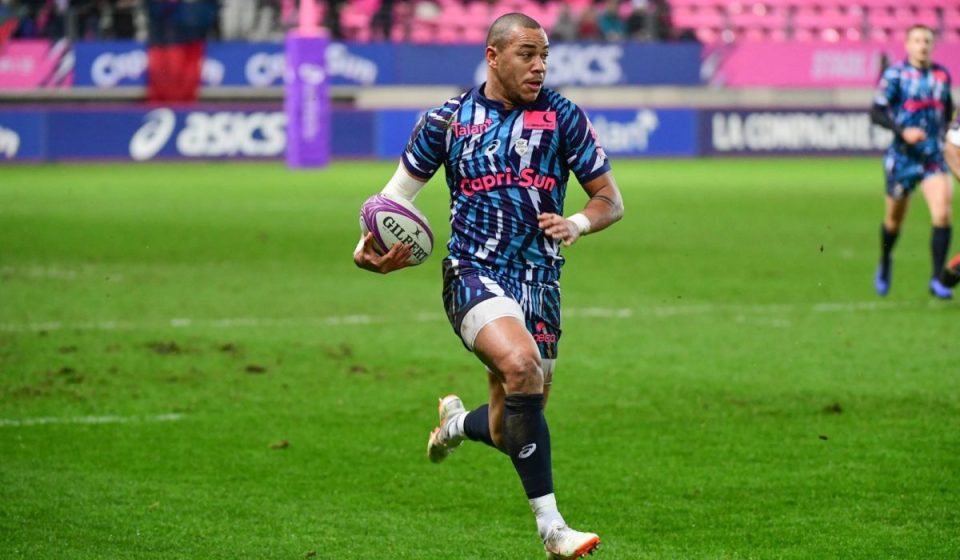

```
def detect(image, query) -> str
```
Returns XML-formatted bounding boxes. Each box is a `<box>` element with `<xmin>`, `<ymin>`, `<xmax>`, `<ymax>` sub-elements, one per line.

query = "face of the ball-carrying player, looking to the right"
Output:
<box><xmin>487</xmin><ymin>27</ymin><xmax>550</xmax><ymax>106</ymax></box>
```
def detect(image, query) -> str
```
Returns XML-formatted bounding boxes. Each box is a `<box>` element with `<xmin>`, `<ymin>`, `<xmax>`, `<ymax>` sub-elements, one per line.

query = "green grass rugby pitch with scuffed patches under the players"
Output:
<box><xmin>0</xmin><ymin>158</ymin><xmax>960</xmax><ymax>560</ymax></box>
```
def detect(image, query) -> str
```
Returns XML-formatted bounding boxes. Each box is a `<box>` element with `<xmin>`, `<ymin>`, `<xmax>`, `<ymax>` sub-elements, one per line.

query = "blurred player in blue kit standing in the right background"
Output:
<box><xmin>870</xmin><ymin>25</ymin><xmax>953</xmax><ymax>299</ymax></box>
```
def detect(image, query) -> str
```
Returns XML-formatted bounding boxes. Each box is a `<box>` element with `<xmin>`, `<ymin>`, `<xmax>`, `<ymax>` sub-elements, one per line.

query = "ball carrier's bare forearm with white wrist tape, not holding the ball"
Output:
<box><xmin>537</xmin><ymin>172</ymin><xmax>623</xmax><ymax>246</ymax></box>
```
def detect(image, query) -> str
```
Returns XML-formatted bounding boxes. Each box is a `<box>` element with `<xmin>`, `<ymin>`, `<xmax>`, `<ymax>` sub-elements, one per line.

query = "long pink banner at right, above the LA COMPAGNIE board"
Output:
<box><xmin>703</xmin><ymin>42</ymin><xmax>960</xmax><ymax>88</ymax></box>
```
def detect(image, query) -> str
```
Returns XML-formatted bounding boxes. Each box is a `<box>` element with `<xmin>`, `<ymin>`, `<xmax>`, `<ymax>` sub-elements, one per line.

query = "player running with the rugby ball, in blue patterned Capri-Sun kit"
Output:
<box><xmin>354</xmin><ymin>13</ymin><xmax>623</xmax><ymax>559</ymax></box>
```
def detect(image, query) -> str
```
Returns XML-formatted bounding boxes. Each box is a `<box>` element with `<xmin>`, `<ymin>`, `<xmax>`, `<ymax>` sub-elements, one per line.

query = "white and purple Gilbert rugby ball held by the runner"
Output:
<box><xmin>360</xmin><ymin>193</ymin><xmax>433</xmax><ymax>265</ymax></box>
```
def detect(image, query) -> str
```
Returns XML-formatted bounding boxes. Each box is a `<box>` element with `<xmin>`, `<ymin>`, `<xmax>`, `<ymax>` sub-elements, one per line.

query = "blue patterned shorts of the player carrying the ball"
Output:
<box><xmin>443</xmin><ymin>259</ymin><xmax>560</xmax><ymax>359</ymax></box>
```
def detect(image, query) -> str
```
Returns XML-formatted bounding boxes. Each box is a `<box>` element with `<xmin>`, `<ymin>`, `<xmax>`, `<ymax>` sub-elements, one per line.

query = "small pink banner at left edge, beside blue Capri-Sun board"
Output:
<box><xmin>0</xmin><ymin>40</ymin><xmax>73</xmax><ymax>90</ymax></box>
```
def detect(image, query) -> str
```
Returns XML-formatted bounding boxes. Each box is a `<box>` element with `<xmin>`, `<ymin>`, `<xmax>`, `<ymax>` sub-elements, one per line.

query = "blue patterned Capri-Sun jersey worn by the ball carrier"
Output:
<box><xmin>402</xmin><ymin>85</ymin><xmax>610</xmax><ymax>282</ymax></box>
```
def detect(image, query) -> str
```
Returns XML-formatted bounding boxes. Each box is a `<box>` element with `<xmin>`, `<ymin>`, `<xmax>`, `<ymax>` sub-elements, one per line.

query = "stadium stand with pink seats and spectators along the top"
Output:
<box><xmin>0</xmin><ymin>0</ymin><xmax>960</xmax><ymax>44</ymax></box>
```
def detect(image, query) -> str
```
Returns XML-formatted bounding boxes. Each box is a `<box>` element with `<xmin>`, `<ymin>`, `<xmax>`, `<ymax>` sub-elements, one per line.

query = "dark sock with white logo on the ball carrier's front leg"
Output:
<box><xmin>503</xmin><ymin>393</ymin><xmax>553</xmax><ymax>499</ymax></box>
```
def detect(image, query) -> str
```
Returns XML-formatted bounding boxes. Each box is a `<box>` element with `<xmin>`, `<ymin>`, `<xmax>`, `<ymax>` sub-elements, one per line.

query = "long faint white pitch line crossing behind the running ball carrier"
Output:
<box><xmin>0</xmin><ymin>301</ymin><xmax>938</xmax><ymax>333</ymax></box>
